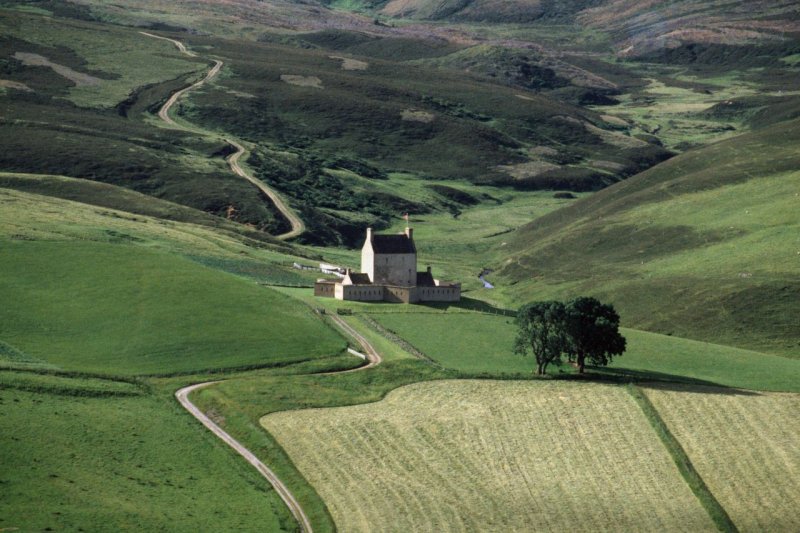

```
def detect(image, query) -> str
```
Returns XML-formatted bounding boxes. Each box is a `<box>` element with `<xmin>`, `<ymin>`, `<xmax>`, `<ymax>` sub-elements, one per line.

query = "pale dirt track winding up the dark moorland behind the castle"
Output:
<box><xmin>139</xmin><ymin>31</ymin><xmax>306</xmax><ymax>241</ymax></box>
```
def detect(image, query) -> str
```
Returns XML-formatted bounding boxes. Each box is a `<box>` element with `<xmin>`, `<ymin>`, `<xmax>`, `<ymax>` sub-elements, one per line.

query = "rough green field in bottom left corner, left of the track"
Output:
<box><xmin>0</xmin><ymin>372</ymin><xmax>293</xmax><ymax>531</ymax></box>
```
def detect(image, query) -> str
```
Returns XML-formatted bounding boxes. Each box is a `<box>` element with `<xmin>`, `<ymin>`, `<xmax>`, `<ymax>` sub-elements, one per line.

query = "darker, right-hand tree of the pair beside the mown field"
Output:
<box><xmin>564</xmin><ymin>296</ymin><xmax>626</xmax><ymax>374</ymax></box>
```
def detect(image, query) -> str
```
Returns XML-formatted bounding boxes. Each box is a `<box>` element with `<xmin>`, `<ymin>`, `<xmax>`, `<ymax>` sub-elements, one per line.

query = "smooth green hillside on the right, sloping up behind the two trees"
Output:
<box><xmin>501</xmin><ymin>116</ymin><xmax>800</xmax><ymax>356</ymax></box>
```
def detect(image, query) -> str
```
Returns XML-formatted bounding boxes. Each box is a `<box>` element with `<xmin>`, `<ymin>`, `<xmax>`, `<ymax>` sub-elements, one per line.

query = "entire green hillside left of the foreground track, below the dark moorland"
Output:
<box><xmin>0</xmin><ymin>182</ymin><xmax>356</xmax><ymax>531</ymax></box>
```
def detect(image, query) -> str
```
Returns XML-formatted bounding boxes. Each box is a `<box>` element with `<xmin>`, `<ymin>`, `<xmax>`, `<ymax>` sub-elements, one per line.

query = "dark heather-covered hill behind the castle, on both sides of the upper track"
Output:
<box><xmin>0</xmin><ymin>4</ymin><xmax>671</xmax><ymax>246</ymax></box>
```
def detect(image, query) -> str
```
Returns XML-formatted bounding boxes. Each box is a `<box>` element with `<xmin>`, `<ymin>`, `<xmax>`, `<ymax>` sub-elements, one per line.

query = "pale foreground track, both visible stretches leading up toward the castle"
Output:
<box><xmin>175</xmin><ymin>315</ymin><xmax>383</xmax><ymax>533</ymax></box>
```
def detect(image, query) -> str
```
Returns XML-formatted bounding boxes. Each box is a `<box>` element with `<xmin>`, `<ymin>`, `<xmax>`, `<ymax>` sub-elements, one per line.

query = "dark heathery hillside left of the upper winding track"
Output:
<box><xmin>0</xmin><ymin>9</ymin><xmax>285</xmax><ymax>233</ymax></box>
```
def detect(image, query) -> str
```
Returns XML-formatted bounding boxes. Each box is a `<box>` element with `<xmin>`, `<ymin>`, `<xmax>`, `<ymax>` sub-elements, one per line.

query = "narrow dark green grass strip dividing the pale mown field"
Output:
<box><xmin>627</xmin><ymin>384</ymin><xmax>739</xmax><ymax>533</ymax></box>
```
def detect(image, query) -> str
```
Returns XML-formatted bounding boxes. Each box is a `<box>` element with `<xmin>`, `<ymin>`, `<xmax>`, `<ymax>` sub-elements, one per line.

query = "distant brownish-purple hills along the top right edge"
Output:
<box><xmin>326</xmin><ymin>0</ymin><xmax>800</xmax><ymax>56</ymax></box>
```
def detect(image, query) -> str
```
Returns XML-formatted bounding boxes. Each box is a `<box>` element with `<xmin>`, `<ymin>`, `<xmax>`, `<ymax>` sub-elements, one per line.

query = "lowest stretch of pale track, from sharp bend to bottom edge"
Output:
<box><xmin>175</xmin><ymin>381</ymin><xmax>313</xmax><ymax>533</ymax></box>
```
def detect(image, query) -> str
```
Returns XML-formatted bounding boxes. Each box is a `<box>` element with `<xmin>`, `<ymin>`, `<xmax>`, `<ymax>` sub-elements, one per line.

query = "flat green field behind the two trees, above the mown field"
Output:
<box><xmin>369</xmin><ymin>310</ymin><xmax>800</xmax><ymax>392</ymax></box>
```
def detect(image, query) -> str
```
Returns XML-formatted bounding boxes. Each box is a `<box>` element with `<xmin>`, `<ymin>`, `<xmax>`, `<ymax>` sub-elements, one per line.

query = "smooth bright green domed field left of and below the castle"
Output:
<box><xmin>0</xmin><ymin>240</ymin><xmax>345</xmax><ymax>375</ymax></box>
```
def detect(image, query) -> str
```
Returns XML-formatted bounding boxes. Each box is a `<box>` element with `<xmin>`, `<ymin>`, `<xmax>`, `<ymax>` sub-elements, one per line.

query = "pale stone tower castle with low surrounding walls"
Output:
<box><xmin>314</xmin><ymin>228</ymin><xmax>461</xmax><ymax>303</ymax></box>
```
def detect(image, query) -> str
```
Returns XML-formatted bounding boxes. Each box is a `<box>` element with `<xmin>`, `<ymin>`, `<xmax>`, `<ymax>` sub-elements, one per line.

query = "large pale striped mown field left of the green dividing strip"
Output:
<box><xmin>262</xmin><ymin>381</ymin><xmax>714</xmax><ymax>531</ymax></box>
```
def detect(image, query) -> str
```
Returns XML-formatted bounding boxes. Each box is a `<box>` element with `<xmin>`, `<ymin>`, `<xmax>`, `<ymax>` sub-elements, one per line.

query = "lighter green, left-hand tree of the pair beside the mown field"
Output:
<box><xmin>514</xmin><ymin>301</ymin><xmax>568</xmax><ymax>376</ymax></box>
